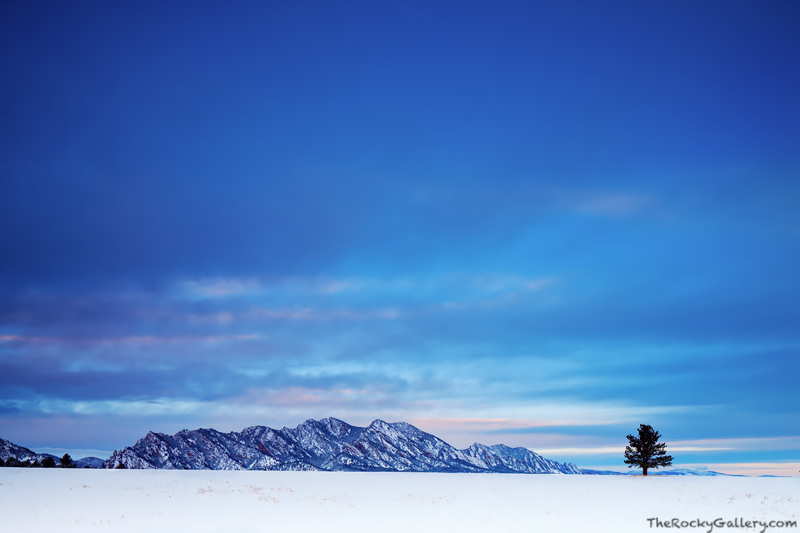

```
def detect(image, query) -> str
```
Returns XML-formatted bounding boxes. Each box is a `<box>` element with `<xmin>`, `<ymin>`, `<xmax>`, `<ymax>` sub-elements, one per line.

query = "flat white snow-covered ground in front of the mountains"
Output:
<box><xmin>0</xmin><ymin>468</ymin><xmax>800</xmax><ymax>533</ymax></box>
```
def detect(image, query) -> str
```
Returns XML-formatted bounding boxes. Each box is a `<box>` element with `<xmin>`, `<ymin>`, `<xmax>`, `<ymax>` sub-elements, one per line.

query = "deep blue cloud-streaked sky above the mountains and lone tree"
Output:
<box><xmin>0</xmin><ymin>0</ymin><xmax>800</xmax><ymax>475</ymax></box>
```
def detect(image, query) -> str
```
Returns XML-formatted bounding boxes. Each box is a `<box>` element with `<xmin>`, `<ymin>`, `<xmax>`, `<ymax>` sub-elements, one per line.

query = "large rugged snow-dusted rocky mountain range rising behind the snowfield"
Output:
<box><xmin>103</xmin><ymin>418</ymin><xmax>582</xmax><ymax>474</ymax></box>
